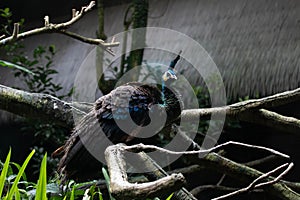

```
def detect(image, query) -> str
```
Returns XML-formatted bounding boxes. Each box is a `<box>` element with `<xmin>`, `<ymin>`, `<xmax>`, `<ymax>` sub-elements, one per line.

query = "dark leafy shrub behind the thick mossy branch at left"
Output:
<box><xmin>0</xmin><ymin>8</ymin><xmax>73</xmax><ymax>180</ymax></box>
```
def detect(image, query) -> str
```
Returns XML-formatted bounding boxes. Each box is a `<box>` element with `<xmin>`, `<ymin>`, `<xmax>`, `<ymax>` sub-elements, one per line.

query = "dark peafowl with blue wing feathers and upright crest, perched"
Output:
<box><xmin>52</xmin><ymin>50</ymin><xmax>182</xmax><ymax>180</ymax></box>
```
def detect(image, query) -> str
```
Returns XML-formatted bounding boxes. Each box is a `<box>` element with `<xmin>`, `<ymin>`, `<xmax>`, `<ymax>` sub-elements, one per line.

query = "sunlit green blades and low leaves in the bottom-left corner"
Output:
<box><xmin>0</xmin><ymin>150</ymin><xmax>177</xmax><ymax>200</ymax></box>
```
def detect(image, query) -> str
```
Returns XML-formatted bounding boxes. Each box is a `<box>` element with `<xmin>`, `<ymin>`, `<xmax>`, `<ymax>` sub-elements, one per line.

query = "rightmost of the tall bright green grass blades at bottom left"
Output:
<box><xmin>35</xmin><ymin>153</ymin><xmax>47</xmax><ymax>200</ymax></box>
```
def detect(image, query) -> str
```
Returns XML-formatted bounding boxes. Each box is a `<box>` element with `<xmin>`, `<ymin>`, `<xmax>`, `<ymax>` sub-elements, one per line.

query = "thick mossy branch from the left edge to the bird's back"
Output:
<box><xmin>0</xmin><ymin>85</ymin><xmax>86</xmax><ymax>128</ymax></box>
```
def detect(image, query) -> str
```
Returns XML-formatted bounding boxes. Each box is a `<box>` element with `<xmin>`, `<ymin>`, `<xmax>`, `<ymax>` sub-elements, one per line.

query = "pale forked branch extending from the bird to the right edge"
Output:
<box><xmin>181</xmin><ymin>88</ymin><xmax>300</xmax><ymax>133</ymax></box>
